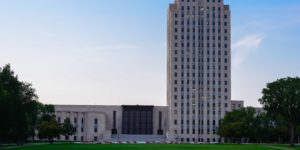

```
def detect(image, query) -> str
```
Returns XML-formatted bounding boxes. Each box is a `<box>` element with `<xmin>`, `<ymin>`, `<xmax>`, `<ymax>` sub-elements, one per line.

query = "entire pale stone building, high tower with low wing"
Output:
<box><xmin>44</xmin><ymin>0</ymin><xmax>244</xmax><ymax>143</ymax></box>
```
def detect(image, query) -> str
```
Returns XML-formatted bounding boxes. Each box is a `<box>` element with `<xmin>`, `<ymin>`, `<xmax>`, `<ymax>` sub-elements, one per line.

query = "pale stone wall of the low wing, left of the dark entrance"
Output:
<box><xmin>55</xmin><ymin>105</ymin><xmax>122</xmax><ymax>142</ymax></box>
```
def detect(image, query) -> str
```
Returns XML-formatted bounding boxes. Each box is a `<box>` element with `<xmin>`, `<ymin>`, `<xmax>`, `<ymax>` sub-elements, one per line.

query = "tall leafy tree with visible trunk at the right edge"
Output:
<box><xmin>259</xmin><ymin>77</ymin><xmax>300</xmax><ymax>146</ymax></box>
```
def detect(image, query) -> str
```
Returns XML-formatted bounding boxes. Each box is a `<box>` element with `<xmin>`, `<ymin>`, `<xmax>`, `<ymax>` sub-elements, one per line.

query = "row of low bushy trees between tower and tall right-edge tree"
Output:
<box><xmin>218</xmin><ymin>107</ymin><xmax>300</xmax><ymax>143</ymax></box>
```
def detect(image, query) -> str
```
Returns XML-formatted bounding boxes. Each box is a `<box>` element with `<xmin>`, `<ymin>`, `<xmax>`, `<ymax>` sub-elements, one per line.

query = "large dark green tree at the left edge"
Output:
<box><xmin>0</xmin><ymin>65</ymin><xmax>39</xmax><ymax>144</ymax></box>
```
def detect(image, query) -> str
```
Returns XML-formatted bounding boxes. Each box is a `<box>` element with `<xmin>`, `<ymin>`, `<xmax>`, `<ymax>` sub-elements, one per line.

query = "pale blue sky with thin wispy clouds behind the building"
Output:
<box><xmin>0</xmin><ymin>0</ymin><xmax>300</xmax><ymax>106</ymax></box>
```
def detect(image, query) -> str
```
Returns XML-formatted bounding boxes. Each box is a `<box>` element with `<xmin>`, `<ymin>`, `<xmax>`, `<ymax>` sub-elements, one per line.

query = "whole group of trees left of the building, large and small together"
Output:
<box><xmin>0</xmin><ymin>64</ymin><xmax>76</xmax><ymax>145</ymax></box>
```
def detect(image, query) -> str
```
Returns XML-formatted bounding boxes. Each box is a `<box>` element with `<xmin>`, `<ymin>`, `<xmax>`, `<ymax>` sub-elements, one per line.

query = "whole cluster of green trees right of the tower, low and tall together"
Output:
<box><xmin>218</xmin><ymin>77</ymin><xmax>300</xmax><ymax>146</ymax></box>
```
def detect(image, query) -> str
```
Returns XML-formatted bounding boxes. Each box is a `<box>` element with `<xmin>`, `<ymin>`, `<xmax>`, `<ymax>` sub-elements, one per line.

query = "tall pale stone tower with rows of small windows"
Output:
<box><xmin>167</xmin><ymin>0</ymin><xmax>231</xmax><ymax>142</ymax></box>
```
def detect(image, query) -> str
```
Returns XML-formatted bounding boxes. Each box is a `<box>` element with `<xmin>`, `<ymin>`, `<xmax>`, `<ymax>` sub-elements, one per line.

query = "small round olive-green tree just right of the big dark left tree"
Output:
<box><xmin>38</xmin><ymin>118</ymin><xmax>61</xmax><ymax>144</ymax></box>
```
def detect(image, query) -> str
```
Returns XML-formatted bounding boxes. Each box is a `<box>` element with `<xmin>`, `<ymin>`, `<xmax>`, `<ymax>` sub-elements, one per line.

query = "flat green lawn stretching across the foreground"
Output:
<box><xmin>0</xmin><ymin>144</ymin><xmax>300</xmax><ymax>150</ymax></box>
